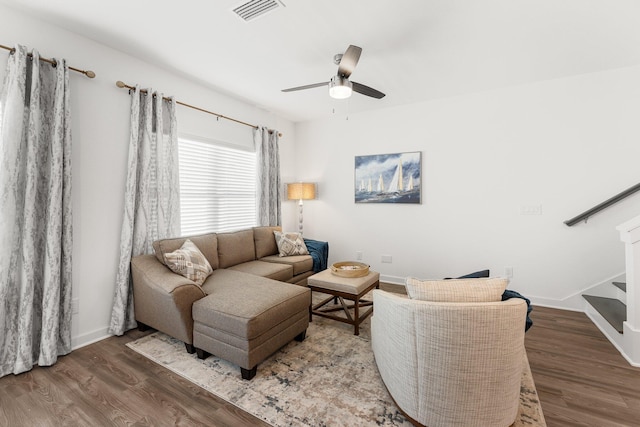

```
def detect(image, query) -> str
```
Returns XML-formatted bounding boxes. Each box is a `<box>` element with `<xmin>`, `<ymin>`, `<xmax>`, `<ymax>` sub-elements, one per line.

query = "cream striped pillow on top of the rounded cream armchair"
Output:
<box><xmin>405</xmin><ymin>277</ymin><xmax>509</xmax><ymax>302</ymax></box>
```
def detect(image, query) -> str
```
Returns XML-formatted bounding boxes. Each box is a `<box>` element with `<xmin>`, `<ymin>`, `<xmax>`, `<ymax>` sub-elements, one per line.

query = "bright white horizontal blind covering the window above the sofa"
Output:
<box><xmin>178</xmin><ymin>137</ymin><xmax>256</xmax><ymax>236</ymax></box>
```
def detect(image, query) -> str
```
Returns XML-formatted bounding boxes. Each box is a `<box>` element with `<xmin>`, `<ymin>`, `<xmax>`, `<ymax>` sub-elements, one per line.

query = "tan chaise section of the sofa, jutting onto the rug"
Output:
<box><xmin>192</xmin><ymin>270</ymin><xmax>311</xmax><ymax>380</ymax></box>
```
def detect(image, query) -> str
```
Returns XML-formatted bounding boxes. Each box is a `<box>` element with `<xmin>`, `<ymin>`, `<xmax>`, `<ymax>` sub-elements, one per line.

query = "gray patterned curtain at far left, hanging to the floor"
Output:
<box><xmin>0</xmin><ymin>46</ymin><xmax>72</xmax><ymax>376</ymax></box>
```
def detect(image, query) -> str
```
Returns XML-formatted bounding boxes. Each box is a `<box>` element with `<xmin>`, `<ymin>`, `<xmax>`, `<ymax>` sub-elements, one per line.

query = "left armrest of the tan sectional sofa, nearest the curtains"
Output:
<box><xmin>131</xmin><ymin>255</ymin><xmax>206</xmax><ymax>344</ymax></box>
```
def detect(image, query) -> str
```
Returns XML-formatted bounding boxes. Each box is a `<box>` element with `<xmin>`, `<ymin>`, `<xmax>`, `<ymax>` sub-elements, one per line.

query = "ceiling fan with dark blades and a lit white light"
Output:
<box><xmin>282</xmin><ymin>45</ymin><xmax>384</xmax><ymax>99</ymax></box>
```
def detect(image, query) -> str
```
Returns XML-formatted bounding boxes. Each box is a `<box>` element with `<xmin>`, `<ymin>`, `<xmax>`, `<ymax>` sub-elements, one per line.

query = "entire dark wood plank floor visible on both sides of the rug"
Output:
<box><xmin>0</xmin><ymin>296</ymin><xmax>640</xmax><ymax>427</ymax></box>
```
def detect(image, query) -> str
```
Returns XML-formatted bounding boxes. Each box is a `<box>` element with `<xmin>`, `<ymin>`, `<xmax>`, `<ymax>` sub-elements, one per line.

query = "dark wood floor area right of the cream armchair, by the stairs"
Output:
<box><xmin>525</xmin><ymin>307</ymin><xmax>640</xmax><ymax>427</ymax></box>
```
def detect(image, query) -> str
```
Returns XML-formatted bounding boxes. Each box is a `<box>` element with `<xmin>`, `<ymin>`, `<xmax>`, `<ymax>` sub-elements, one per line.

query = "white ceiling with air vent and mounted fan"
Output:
<box><xmin>0</xmin><ymin>0</ymin><xmax>640</xmax><ymax>121</ymax></box>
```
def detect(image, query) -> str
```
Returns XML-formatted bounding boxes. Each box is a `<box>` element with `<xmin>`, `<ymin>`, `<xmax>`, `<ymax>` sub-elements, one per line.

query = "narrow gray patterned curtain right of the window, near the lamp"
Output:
<box><xmin>253</xmin><ymin>127</ymin><xmax>282</xmax><ymax>226</ymax></box>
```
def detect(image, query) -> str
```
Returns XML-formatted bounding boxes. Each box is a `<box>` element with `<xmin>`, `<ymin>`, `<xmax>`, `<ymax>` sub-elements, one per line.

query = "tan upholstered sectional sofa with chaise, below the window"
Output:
<box><xmin>131</xmin><ymin>227</ymin><xmax>314</xmax><ymax>379</ymax></box>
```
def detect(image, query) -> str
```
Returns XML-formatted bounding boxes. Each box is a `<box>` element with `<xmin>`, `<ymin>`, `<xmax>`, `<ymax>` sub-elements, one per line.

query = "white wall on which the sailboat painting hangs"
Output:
<box><xmin>292</xmin><ymin>66</ymin><xmax>640</xmax><ymax>306</ymax></box>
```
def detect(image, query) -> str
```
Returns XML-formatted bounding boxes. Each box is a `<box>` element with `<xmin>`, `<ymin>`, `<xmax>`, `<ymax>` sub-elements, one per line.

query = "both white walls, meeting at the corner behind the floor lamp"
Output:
<box><xmin>0</xmin><ymin>6</ymin><xmax>640</xmax><ymax>346</ymax></box>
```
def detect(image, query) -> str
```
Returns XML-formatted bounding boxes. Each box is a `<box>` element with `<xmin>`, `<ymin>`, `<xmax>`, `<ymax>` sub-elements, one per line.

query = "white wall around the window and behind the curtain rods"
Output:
<box><xmin>0</xmin><ymin>6</ymin><xmax>295</xmax><ymax>347</ymax></box>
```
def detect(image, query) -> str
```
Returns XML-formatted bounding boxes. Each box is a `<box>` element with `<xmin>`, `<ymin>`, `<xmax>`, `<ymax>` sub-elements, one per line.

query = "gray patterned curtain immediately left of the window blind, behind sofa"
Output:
<box><xmin>109</xmin><ymin>86</ymin><xmax>180</xmax><ymax>335</ymax></box>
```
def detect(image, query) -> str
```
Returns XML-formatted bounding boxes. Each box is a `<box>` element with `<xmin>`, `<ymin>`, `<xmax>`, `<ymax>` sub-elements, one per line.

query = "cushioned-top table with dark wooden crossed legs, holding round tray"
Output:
<box><xmin>307</xmin><ymin>270</ymin><xmax>380</xmax><ymax>335</ymax></box>
